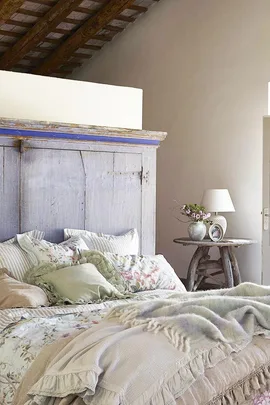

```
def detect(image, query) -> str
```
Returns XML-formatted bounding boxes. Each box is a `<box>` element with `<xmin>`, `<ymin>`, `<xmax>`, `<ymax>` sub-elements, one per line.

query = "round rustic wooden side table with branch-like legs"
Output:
<box><xmin>173</xmin><ymin>238</ymin><xmax>257</xmax><ymax>291</ymax></box>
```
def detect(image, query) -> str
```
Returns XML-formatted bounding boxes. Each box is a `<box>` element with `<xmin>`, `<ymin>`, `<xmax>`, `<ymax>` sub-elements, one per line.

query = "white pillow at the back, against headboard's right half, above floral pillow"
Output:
<box><xmin>64</xmin><ymin>229</ymin><xmax>140</xmax><ymax>255</ymax></box>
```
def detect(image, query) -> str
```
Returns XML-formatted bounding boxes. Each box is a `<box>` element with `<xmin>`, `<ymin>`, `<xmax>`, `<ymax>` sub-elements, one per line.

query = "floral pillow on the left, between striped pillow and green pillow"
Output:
<box><xmin>17</xmin><ymin>235</ymin><xmax>88</xmax><ymax>266</ymax></box>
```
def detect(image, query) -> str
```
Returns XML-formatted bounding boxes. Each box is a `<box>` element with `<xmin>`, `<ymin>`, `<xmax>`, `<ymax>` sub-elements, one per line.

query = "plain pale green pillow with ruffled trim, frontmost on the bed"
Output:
<box><xmin>39</xmin><ymin>263</ymin><xmax>123</xmax><ymax>304</ymax></box>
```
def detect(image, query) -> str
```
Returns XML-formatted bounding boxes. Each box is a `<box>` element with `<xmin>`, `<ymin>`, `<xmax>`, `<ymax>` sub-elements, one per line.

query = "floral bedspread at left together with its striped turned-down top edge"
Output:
<box><xmin>0</xmin><ymin>290</ymin><xmax>172</xmax><ymax>405</ymax></box>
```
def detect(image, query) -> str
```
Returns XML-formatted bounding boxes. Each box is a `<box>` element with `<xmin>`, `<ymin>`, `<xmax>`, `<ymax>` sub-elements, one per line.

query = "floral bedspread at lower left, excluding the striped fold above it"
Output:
<box><xmin>0</xmin><ymin>310</ymin><xmax>106</xmax><ymax>405</ymax></box>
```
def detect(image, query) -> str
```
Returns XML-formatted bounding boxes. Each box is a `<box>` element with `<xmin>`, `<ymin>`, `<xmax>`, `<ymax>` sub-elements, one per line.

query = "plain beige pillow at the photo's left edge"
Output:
<box><xmin>0</xmin><ymin>269</ymin><xmax>49</xmax><ymax>309</ymax></box>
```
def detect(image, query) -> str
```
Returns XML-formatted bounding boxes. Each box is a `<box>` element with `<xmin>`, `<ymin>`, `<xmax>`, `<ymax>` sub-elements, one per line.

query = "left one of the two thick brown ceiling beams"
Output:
<box><xmin>0</xmin><ymin>0</ymin><xmax>84</xmax><ymax>70</ymax></box>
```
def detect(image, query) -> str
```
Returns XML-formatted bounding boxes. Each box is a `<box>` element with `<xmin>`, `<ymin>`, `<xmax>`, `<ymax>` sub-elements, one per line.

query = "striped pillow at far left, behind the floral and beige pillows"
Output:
<box><xmin>0</xmin><ymin>230</ymin><xmax>45</xmax><ymax>281</ymax></box>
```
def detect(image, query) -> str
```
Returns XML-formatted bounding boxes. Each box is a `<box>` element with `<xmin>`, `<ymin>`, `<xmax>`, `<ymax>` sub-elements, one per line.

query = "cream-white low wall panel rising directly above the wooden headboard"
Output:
<box><xmin>0</xmin><ymin>70</ymin><xmax>142</xmax><ymax>129</ymax></box>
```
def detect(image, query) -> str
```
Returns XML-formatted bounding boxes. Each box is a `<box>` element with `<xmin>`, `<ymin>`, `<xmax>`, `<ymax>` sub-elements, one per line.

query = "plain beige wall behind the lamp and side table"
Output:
<box><xmin>71</xmin><ymin>0</ymin><xmax>270</xmax><ymax>282</ymax></box>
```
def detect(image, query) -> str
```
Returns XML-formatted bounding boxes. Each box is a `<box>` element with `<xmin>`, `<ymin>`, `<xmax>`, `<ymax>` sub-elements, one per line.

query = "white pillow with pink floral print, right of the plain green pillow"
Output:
<box><xmin>104</xmin><ymin>252</ymin><xmax>186</xmax><ymax>293</ymax></box>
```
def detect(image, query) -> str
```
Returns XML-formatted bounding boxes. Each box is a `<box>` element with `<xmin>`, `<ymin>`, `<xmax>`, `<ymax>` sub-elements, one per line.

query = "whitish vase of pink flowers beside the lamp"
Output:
<box><xmin>181</xmin><ymin>204</ymin><xmax>211</xmax><ymax>241</ymax></box>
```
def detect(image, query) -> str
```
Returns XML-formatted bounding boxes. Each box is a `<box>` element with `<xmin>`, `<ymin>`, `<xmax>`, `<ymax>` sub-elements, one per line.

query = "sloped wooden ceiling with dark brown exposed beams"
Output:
<box><xmin>0</xmin><ymin>0</ymin><xmax>158</xmax><ymax>77</ymax></box>
